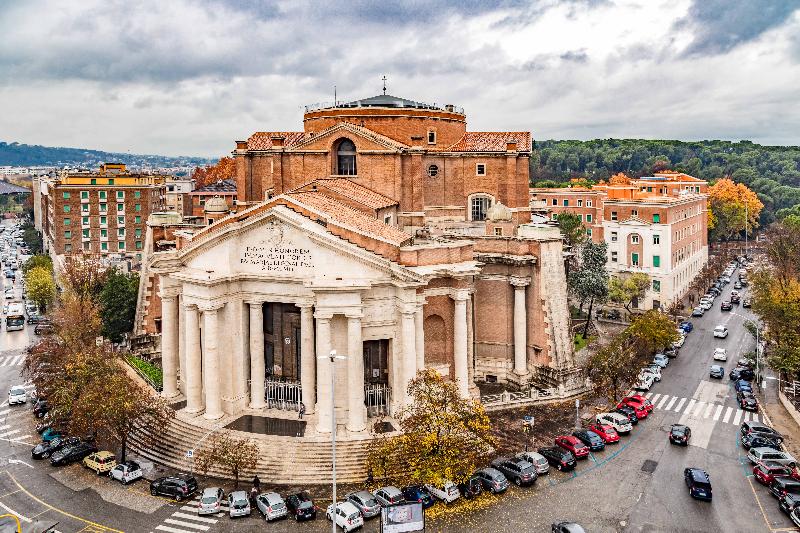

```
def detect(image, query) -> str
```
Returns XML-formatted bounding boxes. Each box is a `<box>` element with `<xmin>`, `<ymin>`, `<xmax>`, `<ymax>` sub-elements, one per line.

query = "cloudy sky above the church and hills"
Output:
<box><xmin>0</xmin><ymin>0</ymin><xmax>800</xmax><ymax>156</ymax></box>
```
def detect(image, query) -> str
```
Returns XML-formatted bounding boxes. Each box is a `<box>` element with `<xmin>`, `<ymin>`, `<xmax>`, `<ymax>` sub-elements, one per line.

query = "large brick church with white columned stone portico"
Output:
<box><xmin>142</xmin><ymin>95</ymin><xmax>583</xmax><ymax>435</ymax></box>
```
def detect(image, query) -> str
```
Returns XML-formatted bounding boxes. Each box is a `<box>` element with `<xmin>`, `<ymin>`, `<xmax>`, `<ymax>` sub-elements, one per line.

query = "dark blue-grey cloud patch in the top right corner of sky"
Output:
<box><xmin>676</xmin><ymin>0</ymin><xmax>800</xmax><ymax>56</ymax></box>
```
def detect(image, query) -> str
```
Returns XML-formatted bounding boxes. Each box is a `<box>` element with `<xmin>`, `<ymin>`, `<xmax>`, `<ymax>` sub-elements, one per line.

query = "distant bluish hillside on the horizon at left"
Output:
<box><xmin>0</xmin><ymin>141</ymin><xmax>214</xmax><ymax>167</ymax></box>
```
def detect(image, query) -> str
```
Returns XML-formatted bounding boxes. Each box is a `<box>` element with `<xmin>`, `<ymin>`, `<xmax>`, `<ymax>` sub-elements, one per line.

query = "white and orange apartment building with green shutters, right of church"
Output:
<box><xmin>531</xmin><ymin>172</ymin><xmax>708</xmax><ymax>309</ymax></box>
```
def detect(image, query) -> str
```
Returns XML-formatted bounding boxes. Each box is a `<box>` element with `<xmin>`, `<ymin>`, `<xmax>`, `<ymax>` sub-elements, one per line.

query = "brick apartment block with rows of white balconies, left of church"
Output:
<box><xmin>34</xmin><ymin>163</ymin><xmax>166</xmax><ymax>259</ymax></box>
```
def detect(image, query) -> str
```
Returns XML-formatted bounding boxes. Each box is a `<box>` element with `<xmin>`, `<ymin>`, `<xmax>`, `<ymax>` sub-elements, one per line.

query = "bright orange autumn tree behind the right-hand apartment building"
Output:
<box><xmin>708</xmin><ymin>178</ymin><xmax>764</xmax><ymax>241</ymax></box>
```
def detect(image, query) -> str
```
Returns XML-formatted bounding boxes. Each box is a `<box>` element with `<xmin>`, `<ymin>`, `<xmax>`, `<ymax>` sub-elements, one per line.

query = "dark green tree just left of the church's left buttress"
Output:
<box><xmin>99</xmin><ymin>269</ymin><xmax>139</xmax><ymax>342</ymax></box>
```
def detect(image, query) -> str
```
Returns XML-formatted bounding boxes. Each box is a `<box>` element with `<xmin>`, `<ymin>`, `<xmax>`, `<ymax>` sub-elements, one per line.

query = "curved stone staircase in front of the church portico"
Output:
<box><xmin>130</xmin><ymin>413</ymin><xmax>370</xmax><ymax>485</ymax></box>
